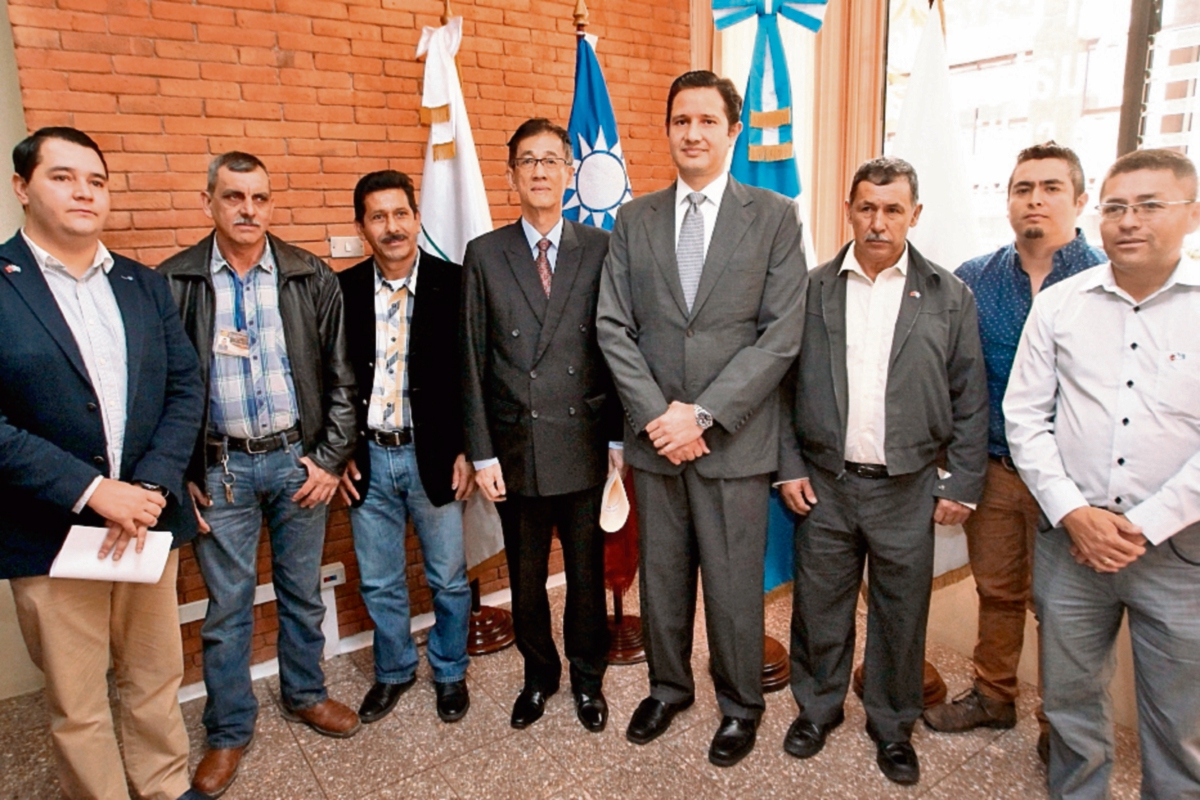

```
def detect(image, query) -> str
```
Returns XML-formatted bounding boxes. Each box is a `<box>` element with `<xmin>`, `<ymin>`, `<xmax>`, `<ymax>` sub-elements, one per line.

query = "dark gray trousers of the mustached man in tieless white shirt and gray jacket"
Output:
<box><xmin>792</xmin><ymin>464</ymin><xmax>937</xmax><ymax>741</ymax></box>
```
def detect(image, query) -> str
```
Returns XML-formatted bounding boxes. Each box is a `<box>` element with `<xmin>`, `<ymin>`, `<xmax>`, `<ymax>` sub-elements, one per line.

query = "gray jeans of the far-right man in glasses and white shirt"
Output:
<box><xmin>1033</xmin><ymin>525</ymin><xmax>1200</xmax><ymax>800</ymax></box>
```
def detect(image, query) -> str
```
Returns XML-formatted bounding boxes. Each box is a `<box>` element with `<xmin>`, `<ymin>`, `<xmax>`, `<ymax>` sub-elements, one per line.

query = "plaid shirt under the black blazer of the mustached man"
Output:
<box><xmin>367</xmin><ymin>251</ymin><xmax>421</xmax><ymax>431</ymax></box>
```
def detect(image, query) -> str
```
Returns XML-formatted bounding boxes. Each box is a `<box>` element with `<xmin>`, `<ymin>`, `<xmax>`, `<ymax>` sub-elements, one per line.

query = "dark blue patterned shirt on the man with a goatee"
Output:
<box><xmin>954</xmin><ymin>228</ymin><xmax>1108</xmax><ymax>457</ymax></box>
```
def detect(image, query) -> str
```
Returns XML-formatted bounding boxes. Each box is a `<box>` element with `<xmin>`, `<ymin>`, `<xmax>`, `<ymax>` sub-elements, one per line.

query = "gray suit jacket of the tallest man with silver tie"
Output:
<box><xmin>596</xmin><ymin>176</ymin><xmax>808</xmax><ymax>479</ymax></box>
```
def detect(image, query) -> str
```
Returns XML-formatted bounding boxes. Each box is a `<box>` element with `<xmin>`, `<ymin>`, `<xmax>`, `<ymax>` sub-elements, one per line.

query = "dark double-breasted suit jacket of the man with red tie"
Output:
<box><xmin>461</xmin><ymin>219</ymin><xmax>620</xmax><ymax>497</ymax></box>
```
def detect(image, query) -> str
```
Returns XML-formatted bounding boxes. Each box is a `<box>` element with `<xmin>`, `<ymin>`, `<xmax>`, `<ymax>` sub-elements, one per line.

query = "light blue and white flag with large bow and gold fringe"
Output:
<box><xmin>713</xmin><ymin>0</ymin><xmax>828</xmax><ymax>593</ymax></box>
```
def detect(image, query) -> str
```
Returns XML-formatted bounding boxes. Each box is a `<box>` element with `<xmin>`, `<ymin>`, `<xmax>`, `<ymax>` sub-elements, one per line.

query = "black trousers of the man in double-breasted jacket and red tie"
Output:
<box><xmin>496</xmin><ymin>486</ymin><xmax>608</xmax><ymax>693</ymax></box>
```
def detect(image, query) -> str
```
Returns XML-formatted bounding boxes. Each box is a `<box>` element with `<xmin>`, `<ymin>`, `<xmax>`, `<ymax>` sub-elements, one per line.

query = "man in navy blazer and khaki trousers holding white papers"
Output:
<box><xmin>0</xmin><ymin>128</ymin><xmax>204</xmax><ymax>800</ymax></box>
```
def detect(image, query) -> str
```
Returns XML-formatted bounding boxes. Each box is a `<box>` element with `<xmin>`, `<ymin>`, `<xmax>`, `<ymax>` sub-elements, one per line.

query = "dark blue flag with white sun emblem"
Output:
<box><xmin>563</xmin><ymin>36</ymin><xmax>634</xmax><ymax>230</ymax></box>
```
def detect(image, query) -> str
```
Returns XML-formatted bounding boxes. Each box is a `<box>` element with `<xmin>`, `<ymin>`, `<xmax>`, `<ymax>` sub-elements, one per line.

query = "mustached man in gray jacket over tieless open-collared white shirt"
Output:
<box><xmin>779</xmin><ymin>158</ymin><xmax>988</xmax><ymax>784</ymax></box>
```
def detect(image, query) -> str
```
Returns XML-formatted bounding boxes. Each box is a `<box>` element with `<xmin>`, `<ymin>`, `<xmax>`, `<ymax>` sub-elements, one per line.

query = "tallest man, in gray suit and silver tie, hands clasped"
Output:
<box><xmin>596</xmin><ymin>72</ymin><xmax>808</xmax><ymax>766</ymax></box>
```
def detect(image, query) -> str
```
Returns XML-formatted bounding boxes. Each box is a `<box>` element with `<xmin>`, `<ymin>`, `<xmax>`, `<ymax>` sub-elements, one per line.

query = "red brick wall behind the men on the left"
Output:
<box><xmin>8</xmin><ymin>0</ymin><xmax>689</xmax><ymax>681</ymax></box>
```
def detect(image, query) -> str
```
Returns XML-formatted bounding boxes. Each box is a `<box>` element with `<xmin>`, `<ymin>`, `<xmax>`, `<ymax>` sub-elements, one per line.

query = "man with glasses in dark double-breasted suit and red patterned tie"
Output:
<box><xmin>462</xmin><ymin>119</ymin><xmax>624</xmax><ymax>732</ymax></box>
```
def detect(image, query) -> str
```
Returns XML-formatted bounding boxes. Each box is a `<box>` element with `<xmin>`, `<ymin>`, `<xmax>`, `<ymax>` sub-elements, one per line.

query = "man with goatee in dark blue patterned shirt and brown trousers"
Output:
<box><xmin>925</xmin><ymin>142</ymin><xmax>1106</xmax><ymax>760</ymax></box>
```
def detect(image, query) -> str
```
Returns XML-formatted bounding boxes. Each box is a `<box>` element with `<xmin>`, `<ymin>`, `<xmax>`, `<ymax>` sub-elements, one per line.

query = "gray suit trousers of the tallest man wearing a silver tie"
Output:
<box><xmin>634</xmin><ymin>467</ymin><xmax>770</xmax><ymax>720</ymax></box>
